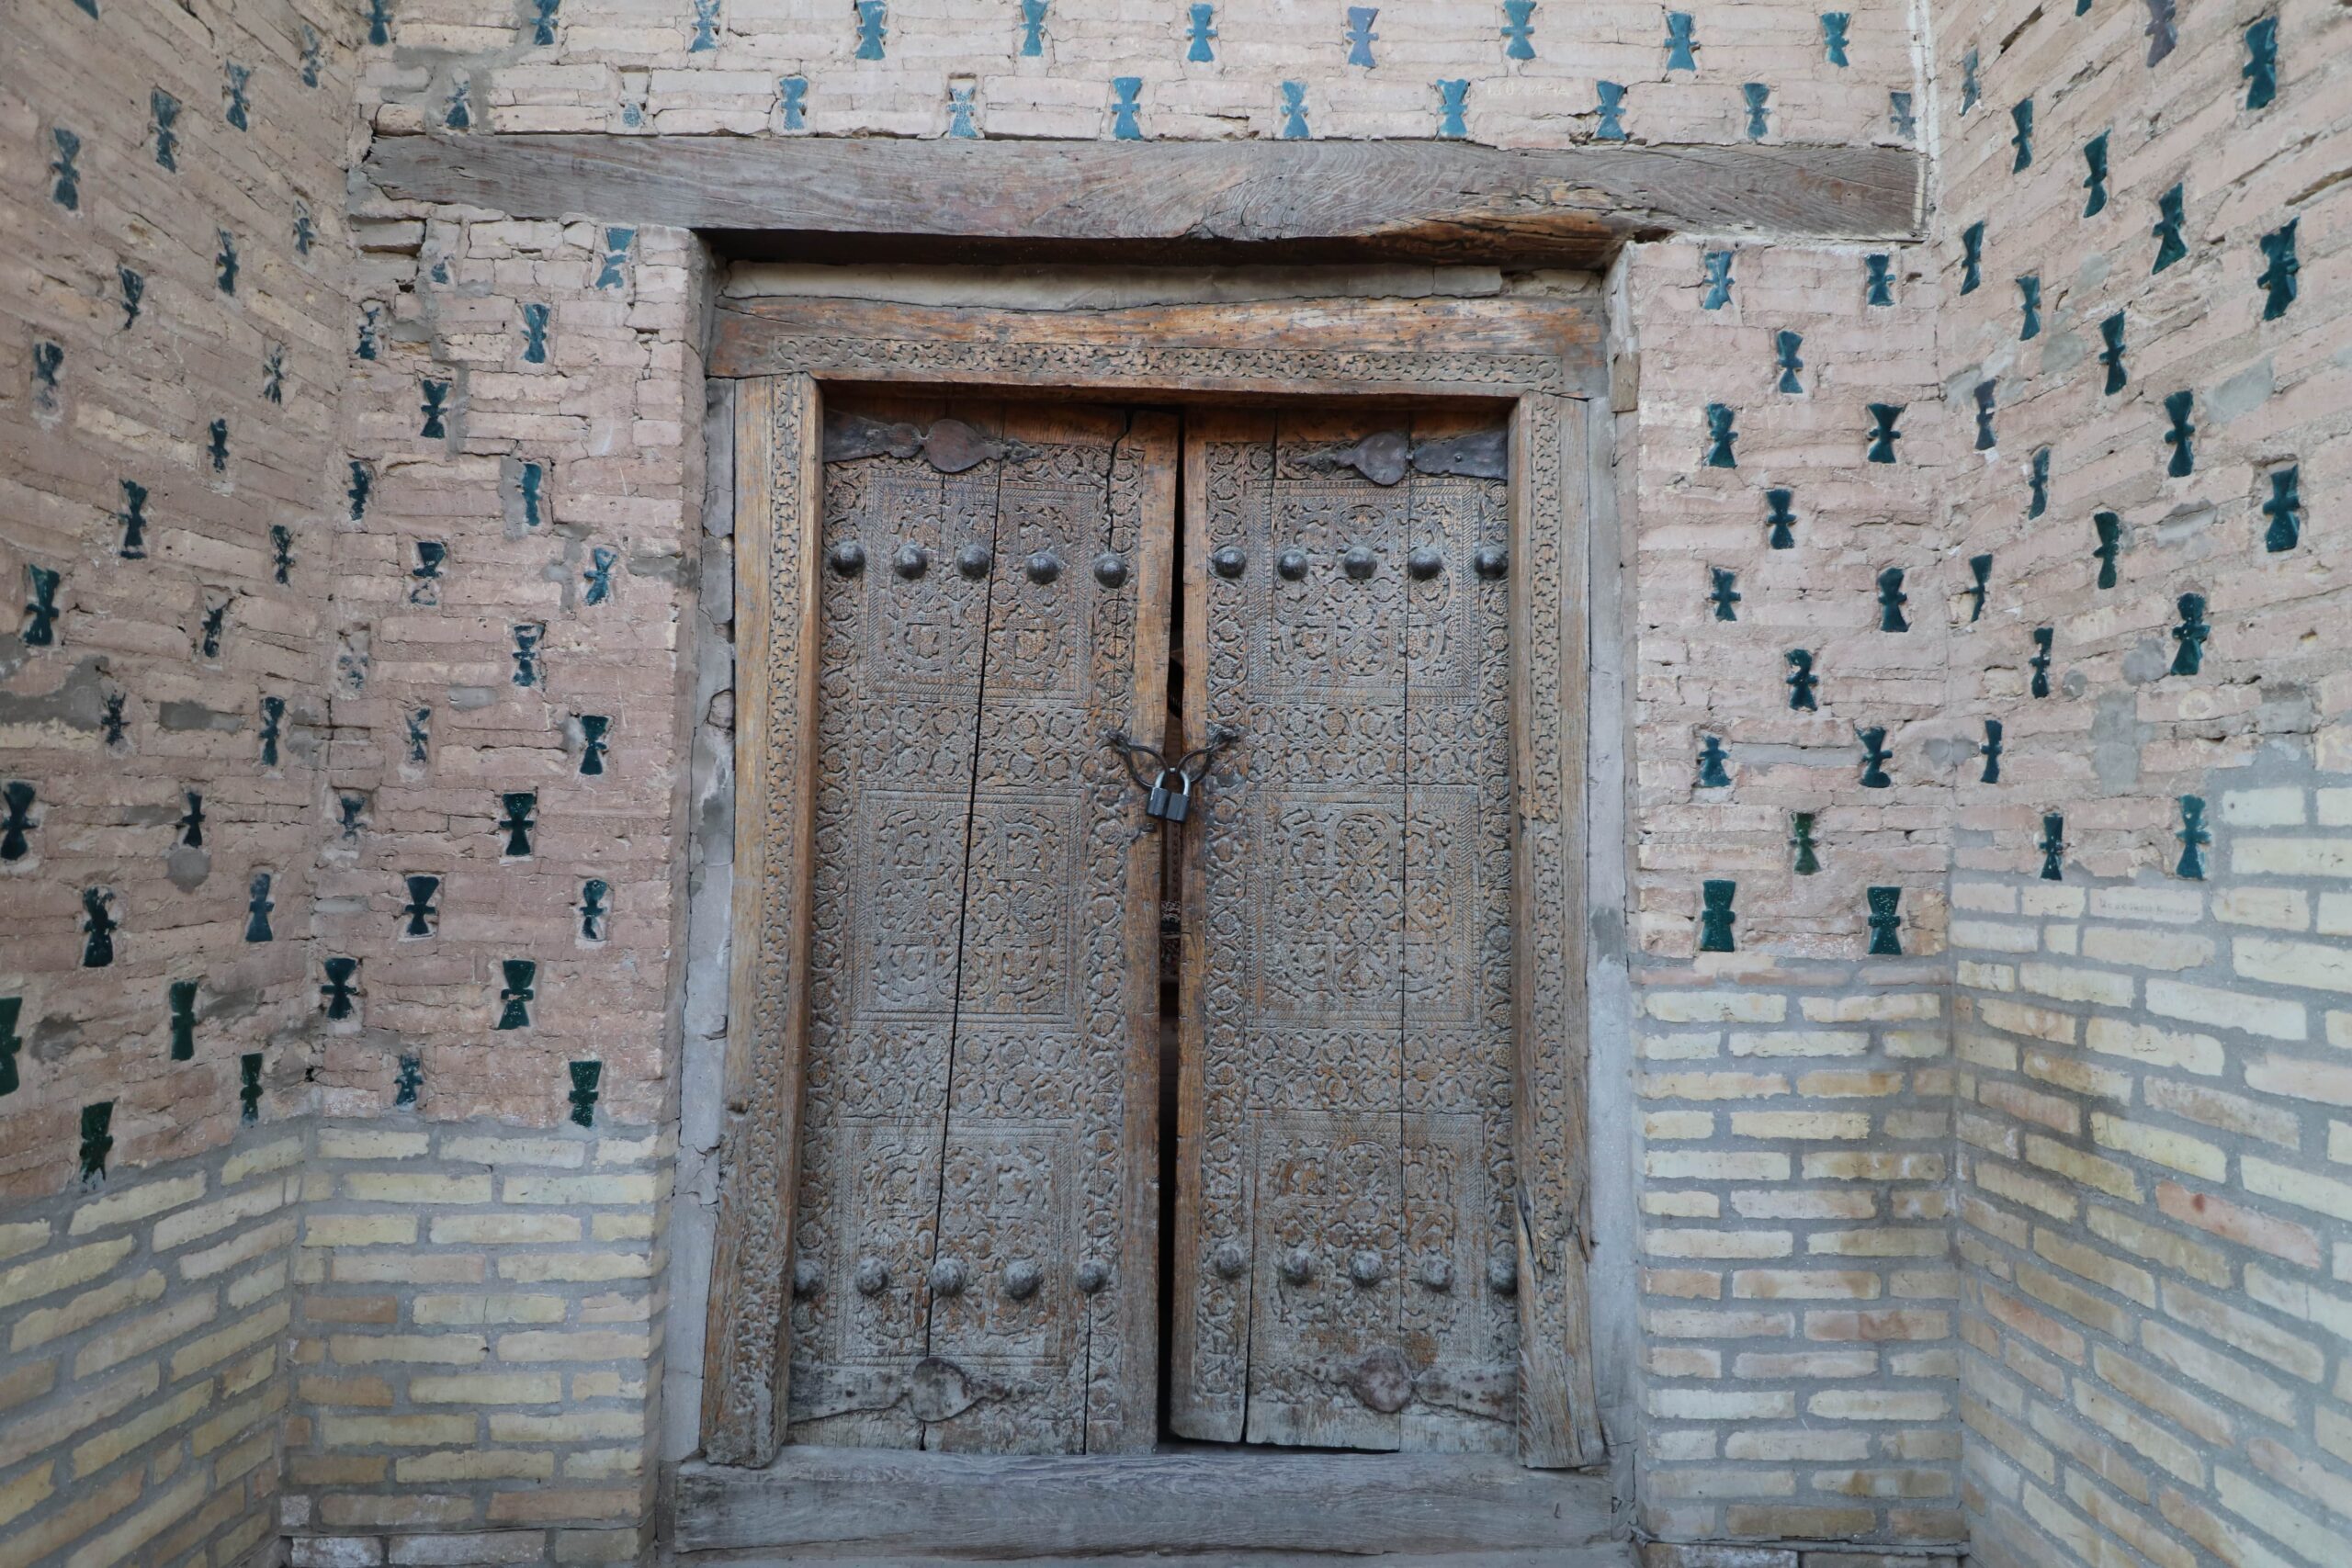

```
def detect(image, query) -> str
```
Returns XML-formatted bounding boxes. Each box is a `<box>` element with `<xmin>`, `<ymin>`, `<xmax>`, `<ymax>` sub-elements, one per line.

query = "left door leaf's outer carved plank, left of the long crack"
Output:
<box><xmin>788</xmin><ymin>389</ymin><xmax>995</xmax><ymax>1448</ymax></box>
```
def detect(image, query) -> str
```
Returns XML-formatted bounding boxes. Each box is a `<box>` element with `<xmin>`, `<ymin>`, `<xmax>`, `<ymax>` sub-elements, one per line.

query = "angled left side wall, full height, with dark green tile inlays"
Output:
<box><xmin>0</xmin><ymin>0</ymin><xmax>353</xmax><ymax>1565</ymax></box>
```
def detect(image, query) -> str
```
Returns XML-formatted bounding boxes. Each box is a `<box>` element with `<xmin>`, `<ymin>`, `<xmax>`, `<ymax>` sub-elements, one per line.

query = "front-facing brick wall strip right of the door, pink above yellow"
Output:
<box><xmin>1611</xmin><ymin>243</ymin><xmax>1971</xmax><ymax>1563</ymax></box>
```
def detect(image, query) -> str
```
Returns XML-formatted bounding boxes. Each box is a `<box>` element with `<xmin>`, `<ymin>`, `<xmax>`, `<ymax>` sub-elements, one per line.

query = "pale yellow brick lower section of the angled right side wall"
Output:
<box><xmin>1954</xmin><ymin>818</ymin><xmax>2352</xmax><ymax>1565</ymax></box>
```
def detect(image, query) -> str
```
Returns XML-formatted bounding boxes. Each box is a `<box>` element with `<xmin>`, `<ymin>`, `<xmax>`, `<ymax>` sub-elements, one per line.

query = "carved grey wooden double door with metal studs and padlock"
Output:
<box><xmin>788</xmin><ymin>402</ymin><xmax>1521</xmax><ymax>1453</ymax></box>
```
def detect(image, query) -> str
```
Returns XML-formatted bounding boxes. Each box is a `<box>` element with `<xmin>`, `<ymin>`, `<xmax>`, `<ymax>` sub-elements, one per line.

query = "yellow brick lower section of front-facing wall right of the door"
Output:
<box><xmin>1634</xmin><ymin>959</ymin><xmax>1962</xmax><ymax>1563</ymax></box>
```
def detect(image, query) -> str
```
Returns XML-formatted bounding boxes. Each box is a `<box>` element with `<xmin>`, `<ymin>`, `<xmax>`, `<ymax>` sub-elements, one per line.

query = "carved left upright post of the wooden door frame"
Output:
<box><xmin>703</xmin><ymin>376</ymin><xmax>823</xmax><ymax>1464</ymax></box>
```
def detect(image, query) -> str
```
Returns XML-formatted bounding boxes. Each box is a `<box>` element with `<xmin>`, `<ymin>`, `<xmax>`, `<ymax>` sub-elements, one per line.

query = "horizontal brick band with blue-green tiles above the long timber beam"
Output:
<box><xmin>353</xmin><ymin>0</ymin><xmax>1917</xmax><ymax>146</ymax></box>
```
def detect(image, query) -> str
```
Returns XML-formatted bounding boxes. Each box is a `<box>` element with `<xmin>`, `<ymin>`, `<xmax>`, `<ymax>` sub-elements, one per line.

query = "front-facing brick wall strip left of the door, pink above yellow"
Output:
<box><xmin>287</xmin><ymin>202</ymin><xmax>703</xmax><ymax>1561</ymax></box>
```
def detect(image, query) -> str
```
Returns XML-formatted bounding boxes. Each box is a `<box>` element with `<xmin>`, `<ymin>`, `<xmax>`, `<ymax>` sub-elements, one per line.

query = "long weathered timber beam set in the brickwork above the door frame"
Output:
<box><xmin>367</xmin><ymin>134</ymin><xmax>1922</xmax><ymax>265</ymax></box>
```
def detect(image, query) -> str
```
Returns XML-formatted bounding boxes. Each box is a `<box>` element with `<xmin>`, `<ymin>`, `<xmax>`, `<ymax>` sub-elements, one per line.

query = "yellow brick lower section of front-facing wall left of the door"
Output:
<box><xmin>287</xmin><ymin>1117</ymin><xmax>675</xmax><ymax>1563</ymax></box>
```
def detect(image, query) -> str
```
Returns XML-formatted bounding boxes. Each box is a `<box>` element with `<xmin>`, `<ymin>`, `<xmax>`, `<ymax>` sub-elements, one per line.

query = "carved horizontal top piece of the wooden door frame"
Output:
<box><xmin>708</xmin><ymin>294</ymin><xmax>1601</xmax><ymax>400</ymax></box>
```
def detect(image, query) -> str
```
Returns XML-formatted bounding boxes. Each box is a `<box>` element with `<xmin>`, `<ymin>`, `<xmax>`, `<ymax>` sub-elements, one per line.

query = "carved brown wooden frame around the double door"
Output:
<box><xmin>701</xmin><ymin>296</ymin><xmax>1606</xmax><ymax>1467</ymax></box>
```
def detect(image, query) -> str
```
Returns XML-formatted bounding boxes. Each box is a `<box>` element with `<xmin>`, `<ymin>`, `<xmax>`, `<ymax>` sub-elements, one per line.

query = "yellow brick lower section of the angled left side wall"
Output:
<box><xmin>0</xmin><ymin>1126</ymin><xmax>308</xmax><ymax>1568</ymax></box>
